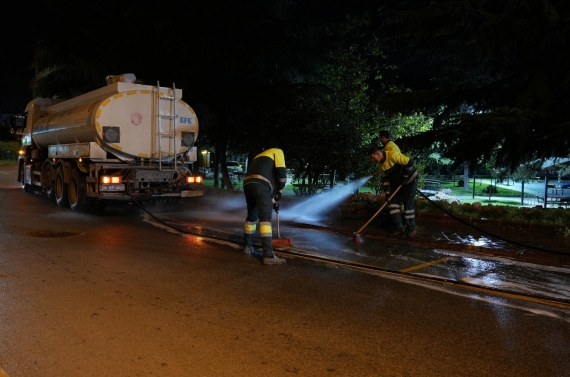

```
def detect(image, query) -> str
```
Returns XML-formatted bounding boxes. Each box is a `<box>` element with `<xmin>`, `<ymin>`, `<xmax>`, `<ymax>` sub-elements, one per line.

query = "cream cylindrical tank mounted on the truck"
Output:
<box><xmin>31</xmin><ymin>83</ymin><xmax>198</xmax><ymax>159</ymax></box>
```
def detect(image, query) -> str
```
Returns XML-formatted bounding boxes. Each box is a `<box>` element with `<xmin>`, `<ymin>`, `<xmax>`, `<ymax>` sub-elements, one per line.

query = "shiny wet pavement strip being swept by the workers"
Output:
<box><xmin>149</xmin><ymin>190</ymin><xmax>570</xmax><ymax>306</ymax></box>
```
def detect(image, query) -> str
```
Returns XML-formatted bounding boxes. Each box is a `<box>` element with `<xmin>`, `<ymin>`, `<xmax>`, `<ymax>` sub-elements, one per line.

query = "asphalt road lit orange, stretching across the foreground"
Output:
<box><xmin>0</xmin><ymin>166</ymin><xmax>570</xmax><ymax>377</ymax></box>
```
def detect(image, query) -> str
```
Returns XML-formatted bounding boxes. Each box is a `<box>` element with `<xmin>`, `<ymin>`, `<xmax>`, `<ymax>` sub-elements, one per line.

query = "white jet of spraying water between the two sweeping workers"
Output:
<box><xmin>281</xmin><ymin>176</ymin><xmax>372</xmax><ymax>222</ymax></box>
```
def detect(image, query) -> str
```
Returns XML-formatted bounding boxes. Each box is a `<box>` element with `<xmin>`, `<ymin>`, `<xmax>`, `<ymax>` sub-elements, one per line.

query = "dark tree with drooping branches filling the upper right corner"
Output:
<box><xmin>370</xmin><ymin>0</ymin><xmax>570</xmax><ymax>170</ymax></box>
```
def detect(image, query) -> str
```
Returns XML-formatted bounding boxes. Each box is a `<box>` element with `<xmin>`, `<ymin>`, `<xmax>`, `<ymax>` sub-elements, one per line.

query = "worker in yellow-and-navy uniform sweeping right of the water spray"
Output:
<box><xmin>368</xmin><ymin>146</ymin><xmax>418</xmax><ymax>237</ymax></box>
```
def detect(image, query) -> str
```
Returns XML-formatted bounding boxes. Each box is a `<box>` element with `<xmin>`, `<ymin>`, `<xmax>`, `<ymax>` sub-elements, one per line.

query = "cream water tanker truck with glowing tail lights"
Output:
<box><xmin>18</xmin><ymin>74</ymin><xmax>204</xmax><ymax>213</ymax></box>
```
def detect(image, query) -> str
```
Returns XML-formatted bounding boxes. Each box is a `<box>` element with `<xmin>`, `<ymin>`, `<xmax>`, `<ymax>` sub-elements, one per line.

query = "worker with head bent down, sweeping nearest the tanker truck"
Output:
<box><xmin>243</xmin><ymin>148</ymin><xmax>287</xmax><ymax>265</ymax></box>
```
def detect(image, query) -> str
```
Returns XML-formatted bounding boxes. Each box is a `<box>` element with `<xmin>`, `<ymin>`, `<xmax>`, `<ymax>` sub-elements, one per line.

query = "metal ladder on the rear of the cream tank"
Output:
<box><xmin>153</xmin><ymin>81</ymin><xmax>176</xmax><ymax>171</ymax></box>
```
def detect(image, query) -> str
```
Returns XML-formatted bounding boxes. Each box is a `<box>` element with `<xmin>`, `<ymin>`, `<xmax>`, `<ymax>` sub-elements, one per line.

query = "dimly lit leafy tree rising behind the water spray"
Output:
<box><xmin>278</xmin><ymin>16</ymin><xmax>384</xmax><ymax>193</ymax></box>
